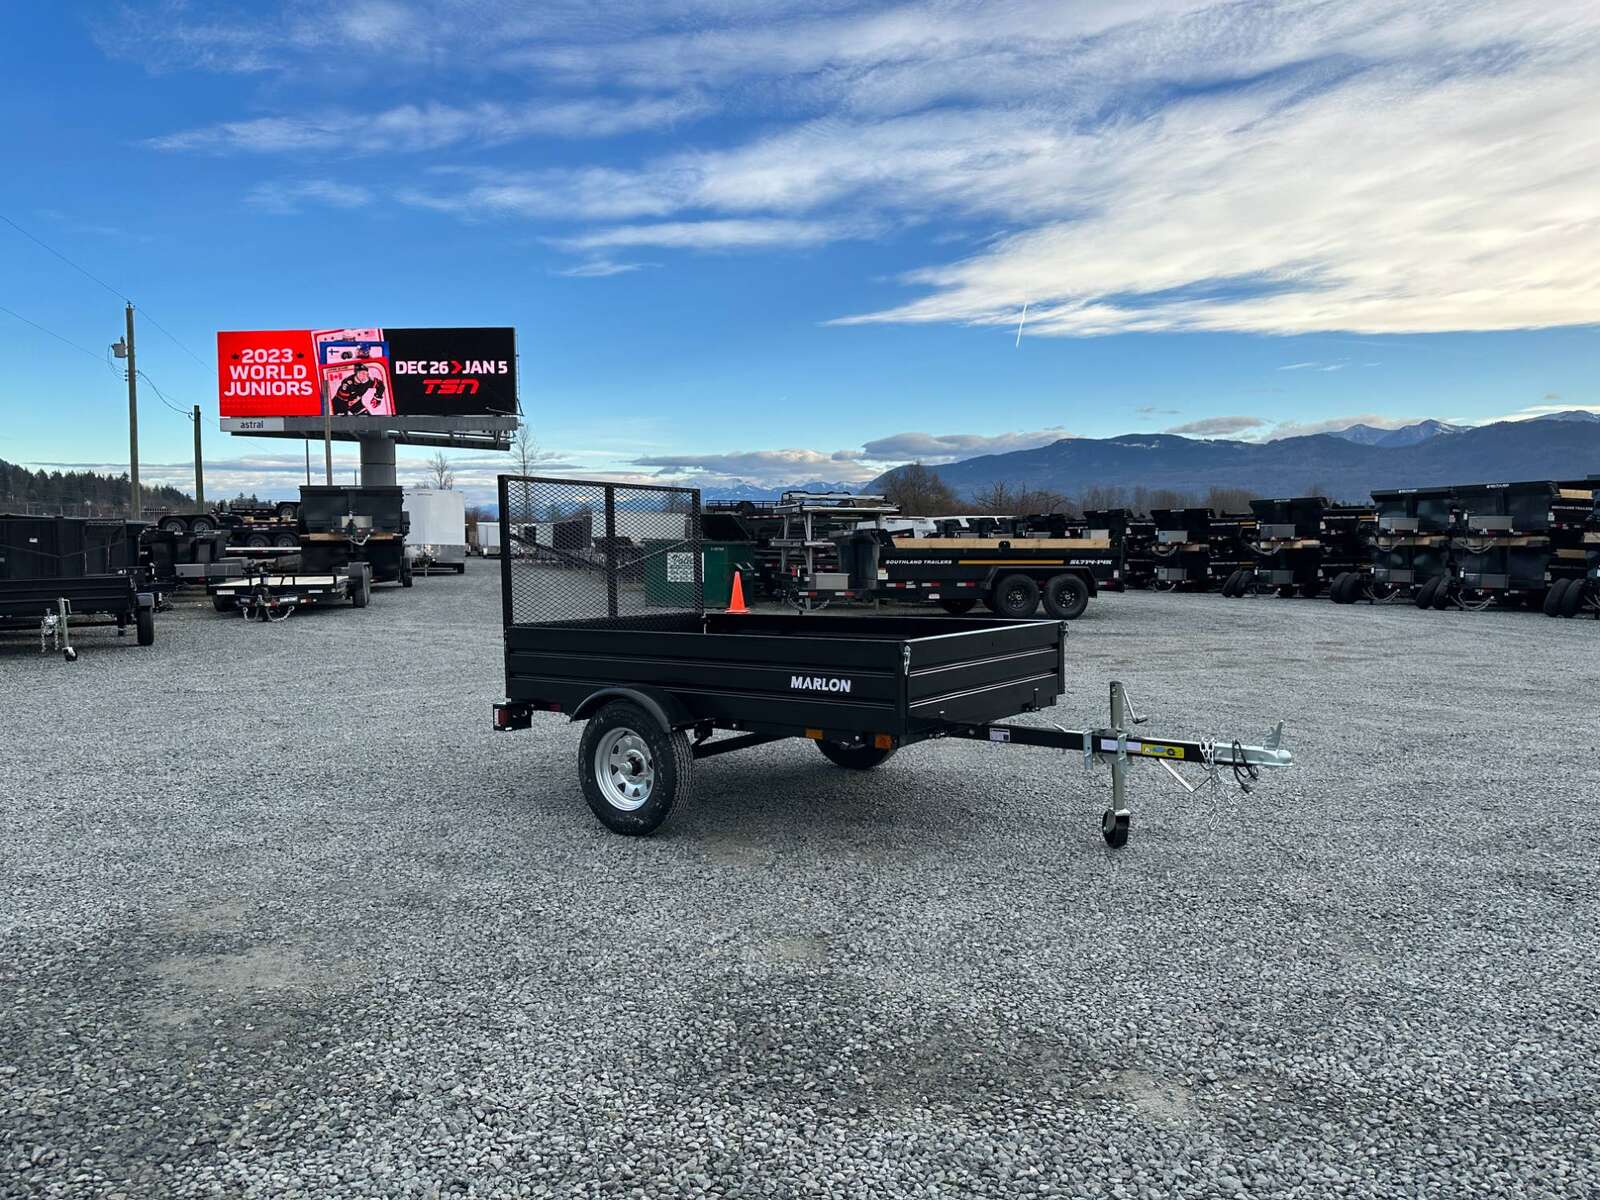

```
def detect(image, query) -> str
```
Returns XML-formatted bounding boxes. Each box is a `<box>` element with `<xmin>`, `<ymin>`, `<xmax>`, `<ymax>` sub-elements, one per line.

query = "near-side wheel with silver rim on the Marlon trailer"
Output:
<box><xmin>578</xmin><ymin>701</ymin><xmax>694</xmax><ymax>837</ymax></box>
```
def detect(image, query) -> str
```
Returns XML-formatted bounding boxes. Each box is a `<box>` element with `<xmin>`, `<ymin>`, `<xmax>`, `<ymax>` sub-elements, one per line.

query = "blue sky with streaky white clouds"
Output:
<box><xmin>0</xmin><ymin>0</ymin><xmax>1600</xmax><ymax>491</ymax></box>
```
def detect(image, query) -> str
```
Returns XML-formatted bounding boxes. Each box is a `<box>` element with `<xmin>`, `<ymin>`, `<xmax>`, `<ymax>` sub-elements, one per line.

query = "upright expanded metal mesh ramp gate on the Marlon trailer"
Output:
<box><xmin>499</xmin><ymin>475</ymin><xmax>706</xmax><ymax>629</ymax></box>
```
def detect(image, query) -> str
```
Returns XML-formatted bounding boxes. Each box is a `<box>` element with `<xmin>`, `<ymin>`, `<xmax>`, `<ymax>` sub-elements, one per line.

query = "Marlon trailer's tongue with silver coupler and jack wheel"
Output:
<box><xmin>949</xmin><ymin>682</ymin><xmax>1294</xmax><ymax>846</ymax></box>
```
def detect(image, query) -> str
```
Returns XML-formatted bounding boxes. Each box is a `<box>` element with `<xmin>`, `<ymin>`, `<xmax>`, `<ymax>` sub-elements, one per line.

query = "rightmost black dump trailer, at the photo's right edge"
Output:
<box><xmin>1452</xmin><ymin>480</ymin><xmax>1594</xmax><ymax>616</ymax></box>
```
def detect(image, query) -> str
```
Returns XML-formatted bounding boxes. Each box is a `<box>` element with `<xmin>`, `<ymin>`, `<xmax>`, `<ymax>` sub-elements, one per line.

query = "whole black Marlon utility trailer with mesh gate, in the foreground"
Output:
<box><xmin>494</xmin><ymin>475</ymin><xmax>1291</xmax><ymax>846</ymax></box>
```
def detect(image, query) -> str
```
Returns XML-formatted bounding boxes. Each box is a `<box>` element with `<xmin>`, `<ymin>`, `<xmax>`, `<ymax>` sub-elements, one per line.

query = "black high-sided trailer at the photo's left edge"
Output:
<box><xmin>0</xmin><ymin>515</ymin><xmax>155</xmax><ymax>662</ymax></box>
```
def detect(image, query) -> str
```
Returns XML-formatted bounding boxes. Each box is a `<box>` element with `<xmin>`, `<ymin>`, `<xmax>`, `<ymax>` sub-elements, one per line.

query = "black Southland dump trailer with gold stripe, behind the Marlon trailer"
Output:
<box><xmin>857</xmin><ymin>530</ymin><xmax>1114</xmax><ymax>621</ymax></box>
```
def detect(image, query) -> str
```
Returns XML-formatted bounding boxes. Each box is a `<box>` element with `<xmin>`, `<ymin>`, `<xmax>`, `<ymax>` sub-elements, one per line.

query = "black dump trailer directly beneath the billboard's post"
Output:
<box><xmin>299</xmin><ymin>485</ymin><xmax>413</xmax><ymax>587</ymax></box>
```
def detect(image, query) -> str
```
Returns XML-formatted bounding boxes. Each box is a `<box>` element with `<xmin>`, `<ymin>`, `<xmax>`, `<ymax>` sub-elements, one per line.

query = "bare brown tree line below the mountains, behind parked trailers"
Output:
<box><xmin>883</xmin><ymin>462</ymin><xmax>1305</xmax><ymax>517</ymax></box>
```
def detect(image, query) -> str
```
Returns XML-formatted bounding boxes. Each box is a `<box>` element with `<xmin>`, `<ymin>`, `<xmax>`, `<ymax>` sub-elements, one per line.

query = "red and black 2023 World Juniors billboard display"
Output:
<box><xmin>216</xmin><ymin>326</ymin><xmax>517</xmax><ymax>421</ymax></box>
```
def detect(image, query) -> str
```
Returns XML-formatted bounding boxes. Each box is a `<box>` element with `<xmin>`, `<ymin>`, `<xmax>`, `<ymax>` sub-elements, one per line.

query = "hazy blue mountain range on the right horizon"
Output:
<box><xmin>869</xmin><ymin>410</ymin><xmax>1600</xmax><ymax>501</ymax></box>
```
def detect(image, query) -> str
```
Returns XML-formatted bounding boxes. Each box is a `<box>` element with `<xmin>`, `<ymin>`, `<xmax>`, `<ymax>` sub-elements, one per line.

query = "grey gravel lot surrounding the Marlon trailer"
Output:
<box><xmin>0</xmin><ymin>563</ymin><xmax>1600</xmax><ymax>1198</ymax></box>
